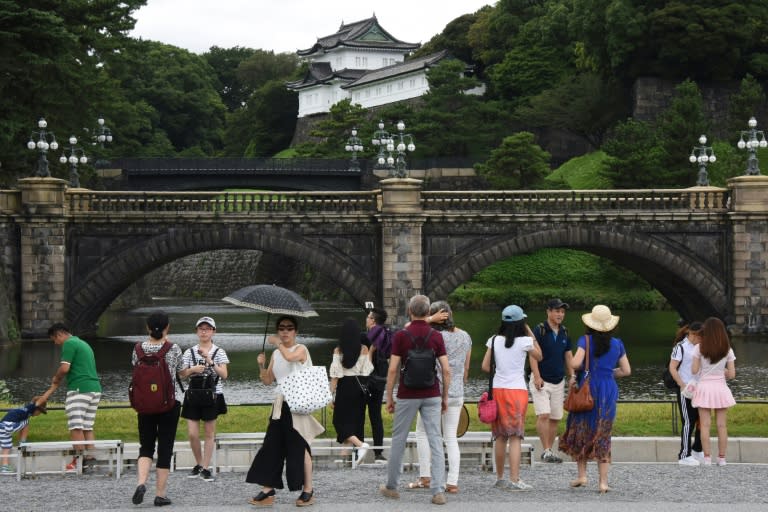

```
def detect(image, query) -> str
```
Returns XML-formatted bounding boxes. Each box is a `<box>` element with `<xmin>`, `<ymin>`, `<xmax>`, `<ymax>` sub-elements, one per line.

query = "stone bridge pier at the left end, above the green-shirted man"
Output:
<box><xmin>18</xmin><ymin>178</ymin><xmax>67</xmax><ymax>338</ymax></box>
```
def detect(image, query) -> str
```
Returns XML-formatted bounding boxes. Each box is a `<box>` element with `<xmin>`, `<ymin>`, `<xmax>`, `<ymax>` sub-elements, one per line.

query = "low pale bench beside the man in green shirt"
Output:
<box><xmin>16</xmin><ymin>439</ymin><xmax>123</xmax><ymax>480</ymax></box>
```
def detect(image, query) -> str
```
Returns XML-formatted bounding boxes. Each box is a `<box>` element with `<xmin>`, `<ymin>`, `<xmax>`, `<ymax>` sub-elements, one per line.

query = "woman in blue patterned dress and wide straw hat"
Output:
<box><xmin>559</xmin><ymin>305</ymin><xmax>631</xmax><ymax>494</ymax></box>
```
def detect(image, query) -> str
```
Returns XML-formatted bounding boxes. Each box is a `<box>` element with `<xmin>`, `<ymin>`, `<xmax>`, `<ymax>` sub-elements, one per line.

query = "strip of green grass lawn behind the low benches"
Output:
<box><xmin>7</xmin><ymin>402</ymin><xmax>768</xmax><ymax>442</ymax></box>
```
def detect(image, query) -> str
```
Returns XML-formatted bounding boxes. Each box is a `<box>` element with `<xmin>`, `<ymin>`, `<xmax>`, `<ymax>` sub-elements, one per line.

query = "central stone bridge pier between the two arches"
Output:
<box><xmin>379</xmin><ymin>178</ymin><xmax>426</xmax><ymax>327</ymax></box>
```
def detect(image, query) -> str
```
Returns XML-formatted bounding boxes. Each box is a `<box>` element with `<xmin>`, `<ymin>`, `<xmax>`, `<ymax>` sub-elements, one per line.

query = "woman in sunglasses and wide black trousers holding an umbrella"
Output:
<box><xmin>245</xmin><ymin>315</ymin><xmax>324</xmax><ymax>507</ymax></box>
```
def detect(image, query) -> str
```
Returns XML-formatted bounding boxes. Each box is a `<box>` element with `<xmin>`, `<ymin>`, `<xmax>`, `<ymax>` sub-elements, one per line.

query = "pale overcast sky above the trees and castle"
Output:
<box><xmin>131</xmin><ymin>0</ymin><xmax>495</xmax><ymax>53</ymax></box>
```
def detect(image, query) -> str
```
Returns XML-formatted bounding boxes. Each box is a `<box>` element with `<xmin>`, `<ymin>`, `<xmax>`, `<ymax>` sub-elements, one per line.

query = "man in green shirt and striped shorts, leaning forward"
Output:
<box><xmin>48</xmin><ymin>323</ymin><xmax>101</xmax><ymax>470</ymax></box>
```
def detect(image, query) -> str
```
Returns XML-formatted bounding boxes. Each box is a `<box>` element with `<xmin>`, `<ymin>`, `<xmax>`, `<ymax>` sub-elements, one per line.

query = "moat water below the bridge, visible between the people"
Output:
<box><xmin>0</xmin><ymin>300</ymin><xmax>768</xmax><ymax>403</ymax></box>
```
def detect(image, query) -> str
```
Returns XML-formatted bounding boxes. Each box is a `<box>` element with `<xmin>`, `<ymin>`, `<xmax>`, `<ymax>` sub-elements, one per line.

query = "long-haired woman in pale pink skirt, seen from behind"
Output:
<box><xmin>691</xmin><ymin>317</ymin><xmax>736</xmax><ymax>466</ymax></box>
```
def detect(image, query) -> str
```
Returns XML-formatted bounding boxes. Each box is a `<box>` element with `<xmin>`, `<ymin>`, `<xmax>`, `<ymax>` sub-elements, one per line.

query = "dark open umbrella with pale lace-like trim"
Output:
<box><xmin>222</xmin><ymin>284</ymin><xmax>318</xmax><ymax>351</ymax></box>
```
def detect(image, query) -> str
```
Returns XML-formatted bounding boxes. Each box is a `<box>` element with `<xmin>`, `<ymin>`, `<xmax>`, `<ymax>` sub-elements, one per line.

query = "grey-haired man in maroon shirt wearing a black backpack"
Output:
<box><xmin>379</xmin><ymin>295</ymin><xmax>451</xmax><ymax>505</ymax></box>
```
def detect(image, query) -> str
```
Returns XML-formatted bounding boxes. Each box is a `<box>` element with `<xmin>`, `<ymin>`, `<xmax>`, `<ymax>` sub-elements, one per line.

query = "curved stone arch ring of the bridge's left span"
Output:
<box><xmin>67</xmin><ymin>226</ymin><xmax>376</xmax><ymax>332</ymax></box>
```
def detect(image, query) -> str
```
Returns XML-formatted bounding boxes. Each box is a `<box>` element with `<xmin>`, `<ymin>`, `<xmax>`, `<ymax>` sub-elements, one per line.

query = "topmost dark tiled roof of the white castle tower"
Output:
<box><xmin>296</xmin><ymin>15</ymin><xmax>421</xmax><ymax>57</ymax></box>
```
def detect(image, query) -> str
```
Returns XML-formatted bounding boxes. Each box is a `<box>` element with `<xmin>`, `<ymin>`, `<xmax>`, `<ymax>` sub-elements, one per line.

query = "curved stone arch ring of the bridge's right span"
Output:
<box><xmin>425</xmin><ymin>226</ymin><xmax>729</xmax><ymax>318</ymax></box>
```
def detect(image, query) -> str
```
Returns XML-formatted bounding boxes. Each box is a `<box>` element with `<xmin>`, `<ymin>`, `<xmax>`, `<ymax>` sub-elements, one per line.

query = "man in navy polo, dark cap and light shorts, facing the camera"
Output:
<box><xmin>528</xmin><ymin>299</ymin><xmax>573</xmax><ymax>462</ymax></box>
